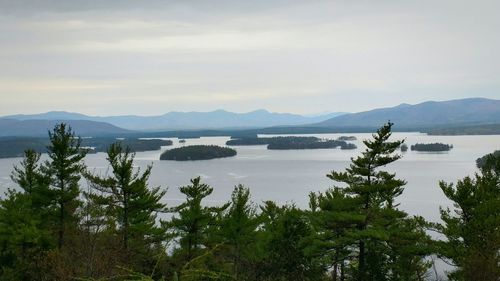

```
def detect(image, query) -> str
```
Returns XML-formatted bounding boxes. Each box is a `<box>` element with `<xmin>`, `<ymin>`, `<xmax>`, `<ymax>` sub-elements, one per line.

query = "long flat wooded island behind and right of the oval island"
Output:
<box><xmin>226</xmin><ymin>136</ymin><xmax>357</xmax><ymax>150</ymax></box>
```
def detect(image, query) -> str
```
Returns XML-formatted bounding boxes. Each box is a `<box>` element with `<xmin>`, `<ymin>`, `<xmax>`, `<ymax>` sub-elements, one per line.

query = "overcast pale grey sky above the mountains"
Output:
<box><xmin>0</xmin><ymin>0</ymin><xmax>500</xmax><ymax>115</ymax></box>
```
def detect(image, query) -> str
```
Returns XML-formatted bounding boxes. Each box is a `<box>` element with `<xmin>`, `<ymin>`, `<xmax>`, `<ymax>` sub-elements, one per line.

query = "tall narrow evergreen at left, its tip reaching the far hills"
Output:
<box><xmin>42</xmin><ymin>123</ymin><xmax>86</xmax><ymax>249</ymax></box>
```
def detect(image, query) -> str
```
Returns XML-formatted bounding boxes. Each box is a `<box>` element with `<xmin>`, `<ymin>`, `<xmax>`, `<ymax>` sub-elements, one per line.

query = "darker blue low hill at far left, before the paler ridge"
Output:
<box><xmin>0</xmin><ymin>118</ymin><xmax>131</xmax><ymax>137</ymax></box>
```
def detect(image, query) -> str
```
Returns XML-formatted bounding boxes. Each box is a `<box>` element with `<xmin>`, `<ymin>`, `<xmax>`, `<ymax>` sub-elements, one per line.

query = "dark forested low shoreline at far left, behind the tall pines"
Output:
<box><xmin>0</xmin><ymin>137</ymin><xmax>172</xmax><ymax>158</ymax></box>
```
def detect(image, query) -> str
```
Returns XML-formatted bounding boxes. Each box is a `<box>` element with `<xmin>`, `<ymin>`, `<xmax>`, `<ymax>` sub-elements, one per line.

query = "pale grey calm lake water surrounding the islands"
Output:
<box><xmin>0</xmin><ymin>133</ymin><xmax>500</xmax><ymax>224</ymax></box>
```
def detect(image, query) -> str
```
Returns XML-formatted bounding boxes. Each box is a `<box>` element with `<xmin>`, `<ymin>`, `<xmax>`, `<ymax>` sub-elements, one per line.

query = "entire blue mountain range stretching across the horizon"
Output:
<box><xmin>0</xmin><ymin>98</ymin><xmax>500</xmax><ymax>136</ymax></box>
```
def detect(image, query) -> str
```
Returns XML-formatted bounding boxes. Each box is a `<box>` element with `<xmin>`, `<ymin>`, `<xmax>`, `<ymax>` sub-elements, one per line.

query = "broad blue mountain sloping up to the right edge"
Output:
<box><xmin>313</xmin><ymin>98</ymin><xmax>500</xmax><ymax>129</ymax></box>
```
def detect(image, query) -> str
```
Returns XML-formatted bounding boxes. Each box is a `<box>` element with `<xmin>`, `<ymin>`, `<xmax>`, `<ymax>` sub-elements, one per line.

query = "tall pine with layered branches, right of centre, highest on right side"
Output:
<box><xmin>324</xmin><ymin>123</ymin><xmax>427</xmax><ymax>280</ymax></box>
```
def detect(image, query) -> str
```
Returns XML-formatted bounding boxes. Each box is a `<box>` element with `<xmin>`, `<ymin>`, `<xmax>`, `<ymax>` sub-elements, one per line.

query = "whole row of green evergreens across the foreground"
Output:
<box><xmin>0</xmin><ymin>123</ymin><xmax>500</xmax><ymax>281</ymax></box>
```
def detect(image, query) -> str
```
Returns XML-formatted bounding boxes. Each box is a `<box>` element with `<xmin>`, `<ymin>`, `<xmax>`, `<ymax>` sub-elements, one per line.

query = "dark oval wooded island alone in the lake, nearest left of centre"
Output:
<box><xmin>160</xmin><ymin>145</ymin><xmax>236</xmax><ymax>161</ymax></box>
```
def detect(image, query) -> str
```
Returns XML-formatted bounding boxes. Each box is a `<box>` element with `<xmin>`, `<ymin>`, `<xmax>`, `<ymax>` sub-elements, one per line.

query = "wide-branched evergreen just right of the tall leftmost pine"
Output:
<box><xmin>85</xmin><ymin>142</ymin><xmax>166</xmax><ymax>262</ymax></box>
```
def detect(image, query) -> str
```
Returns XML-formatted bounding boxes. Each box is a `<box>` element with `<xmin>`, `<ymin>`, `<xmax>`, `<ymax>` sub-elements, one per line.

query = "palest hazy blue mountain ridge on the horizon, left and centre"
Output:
<box><xmin>4</xmin><ymin>109</ymin><xmax>342</xmax><ymax>131</ymax></box>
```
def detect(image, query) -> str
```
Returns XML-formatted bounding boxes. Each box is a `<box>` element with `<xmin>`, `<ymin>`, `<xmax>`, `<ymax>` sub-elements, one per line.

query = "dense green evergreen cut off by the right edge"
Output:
<box><xmin>438</xmin><ymin>152</ymin><xmax>500</xmax><ymax>281</ymax></box>
